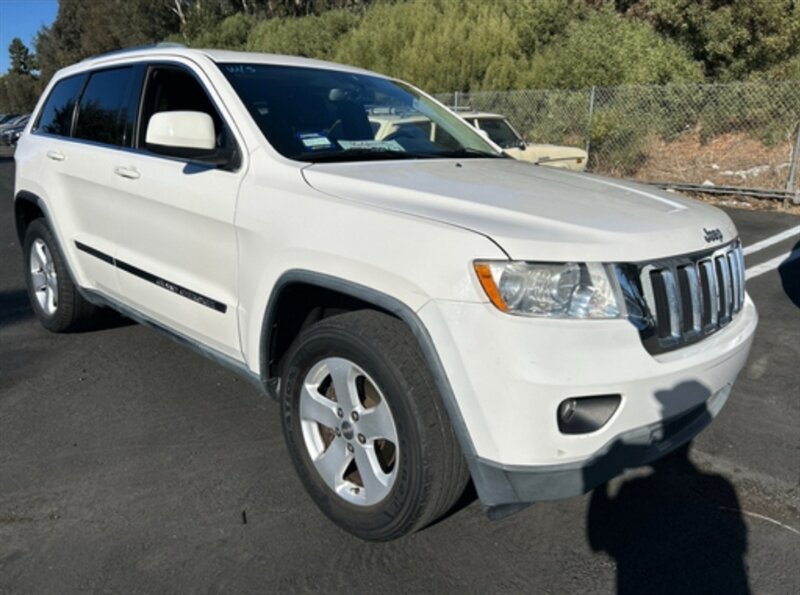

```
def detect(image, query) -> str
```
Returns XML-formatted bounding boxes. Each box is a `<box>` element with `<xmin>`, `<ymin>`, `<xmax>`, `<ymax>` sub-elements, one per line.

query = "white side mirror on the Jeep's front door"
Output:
<box><xmin>145</xmin><ymin>111</ymin><xmax>217</xmax><ymax>157</ymax></box>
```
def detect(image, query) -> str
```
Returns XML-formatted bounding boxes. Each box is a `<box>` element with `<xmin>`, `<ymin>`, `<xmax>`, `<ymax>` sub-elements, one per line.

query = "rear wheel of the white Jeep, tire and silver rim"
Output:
<box><xmin>23</xmin><ymin>219</ymin><xmax>96</xmax><ymax>333</ymax></box>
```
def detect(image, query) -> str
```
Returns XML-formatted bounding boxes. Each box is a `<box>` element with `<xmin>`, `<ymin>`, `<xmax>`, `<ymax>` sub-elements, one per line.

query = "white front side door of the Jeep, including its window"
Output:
<box><xmin>112</xmin><ymin>63</ymin><xmax>244</xmax><ymax>359</ymax></box>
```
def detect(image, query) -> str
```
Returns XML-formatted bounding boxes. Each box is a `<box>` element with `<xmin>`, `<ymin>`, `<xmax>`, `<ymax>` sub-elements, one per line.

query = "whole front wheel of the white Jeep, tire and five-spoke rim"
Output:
<box><xmin>281</xmin><ymin>310</ymin><xmax>469</xmax><ymax>541</ymax></box>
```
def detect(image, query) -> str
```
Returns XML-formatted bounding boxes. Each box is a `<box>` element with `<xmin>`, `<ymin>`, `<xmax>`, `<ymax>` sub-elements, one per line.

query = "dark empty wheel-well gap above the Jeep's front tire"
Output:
<box><xmin>262</xmin><ymin>282</ymin><xmax>395</xmax><ymax>378</ymax></box>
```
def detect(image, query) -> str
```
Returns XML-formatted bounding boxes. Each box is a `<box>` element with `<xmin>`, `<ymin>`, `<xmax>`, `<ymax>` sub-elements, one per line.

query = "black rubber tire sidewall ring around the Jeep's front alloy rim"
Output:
<box><xmin>281</xmin><ymin>327</ymin><xmax>424</xmax><ymax>540</ymax></box>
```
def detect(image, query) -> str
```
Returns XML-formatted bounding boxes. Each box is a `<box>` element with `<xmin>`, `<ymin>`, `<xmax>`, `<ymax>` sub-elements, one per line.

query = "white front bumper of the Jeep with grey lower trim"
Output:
<box><xmin>419</xmin><ymin>298</ymin><xmax>758</xmax><ymax>507</ymax></box>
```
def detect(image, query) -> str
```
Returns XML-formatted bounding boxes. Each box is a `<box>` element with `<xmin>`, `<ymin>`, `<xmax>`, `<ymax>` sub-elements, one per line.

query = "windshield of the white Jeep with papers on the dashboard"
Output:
<box><xmin>220</xmin><ymin>63</ymin><xmax>501</xmax><ymax>162</ymax></box>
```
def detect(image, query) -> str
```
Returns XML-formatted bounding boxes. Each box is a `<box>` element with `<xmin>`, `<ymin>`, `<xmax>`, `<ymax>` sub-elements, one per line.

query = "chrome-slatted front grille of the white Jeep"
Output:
<box><xmin>618</xmin><ymin>241</ymin><xmax>745</xmax><ymax>353</ymax></box>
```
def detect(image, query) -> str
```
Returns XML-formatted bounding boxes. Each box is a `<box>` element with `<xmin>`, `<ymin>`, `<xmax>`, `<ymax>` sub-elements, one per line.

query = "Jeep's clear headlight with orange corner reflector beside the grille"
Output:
<box><xmin>474</xmin><ymin>261</ymin><xmax>621</xmax><ymax>318</ymax></box>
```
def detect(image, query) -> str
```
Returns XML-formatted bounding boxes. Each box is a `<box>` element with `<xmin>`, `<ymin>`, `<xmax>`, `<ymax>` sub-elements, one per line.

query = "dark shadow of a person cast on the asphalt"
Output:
<box><xmin>587</xmin><ymin>444</ymin><xmax>751</xmax><ymax>595</ymax></box>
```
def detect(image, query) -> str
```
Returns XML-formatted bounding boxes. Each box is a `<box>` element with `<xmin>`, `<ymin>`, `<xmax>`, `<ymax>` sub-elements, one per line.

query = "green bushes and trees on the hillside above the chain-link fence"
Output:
<box><xmin>0</xmin><ymin>0</ymin><xmax>800</xmax><ymax>112</ymax></box>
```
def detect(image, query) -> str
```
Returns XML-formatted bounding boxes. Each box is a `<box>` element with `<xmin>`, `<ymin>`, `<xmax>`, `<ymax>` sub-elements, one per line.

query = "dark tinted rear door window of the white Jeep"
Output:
<box><xmin>73</xmin><ymin>67</ymin><xmax>133</xmax><ymax>146</ymax></box>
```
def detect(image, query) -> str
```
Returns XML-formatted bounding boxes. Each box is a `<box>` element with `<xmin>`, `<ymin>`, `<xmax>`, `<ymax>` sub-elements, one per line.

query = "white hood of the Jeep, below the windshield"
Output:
<box><xmin>303</xmin><ymin>159</ymin><xmax>736</xmax><ymax>262</ymax></box>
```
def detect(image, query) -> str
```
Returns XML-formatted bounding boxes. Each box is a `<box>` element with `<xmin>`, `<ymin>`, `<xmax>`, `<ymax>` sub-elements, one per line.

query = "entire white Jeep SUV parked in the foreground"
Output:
<box><xmin>14</xmin><ymin>47</ymin><xmax>757</xmax><ymax>540</ymax></box>
